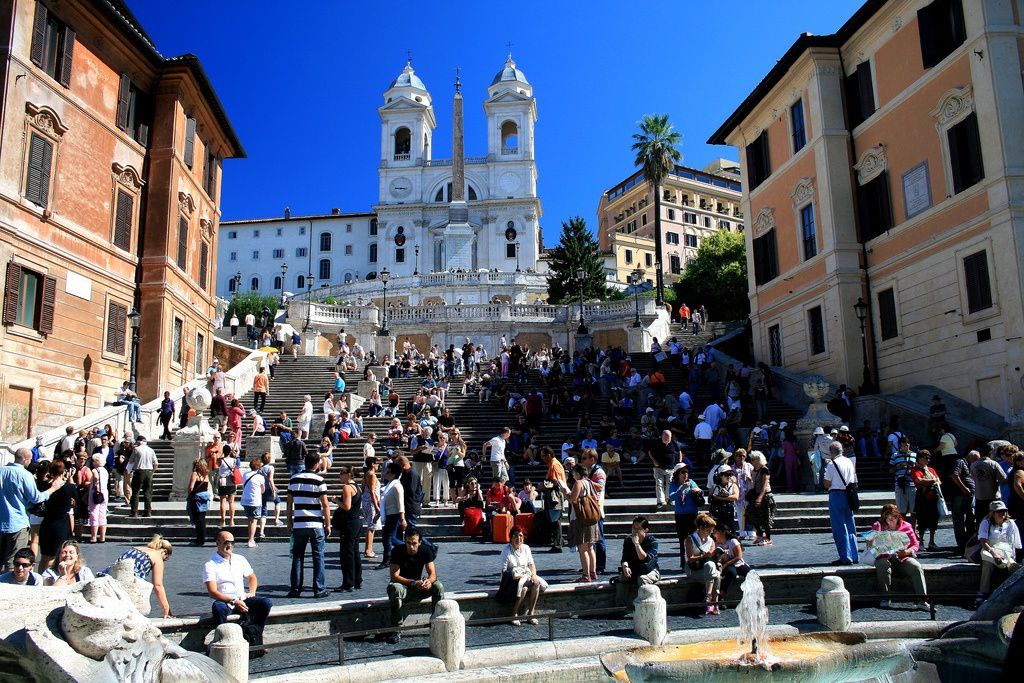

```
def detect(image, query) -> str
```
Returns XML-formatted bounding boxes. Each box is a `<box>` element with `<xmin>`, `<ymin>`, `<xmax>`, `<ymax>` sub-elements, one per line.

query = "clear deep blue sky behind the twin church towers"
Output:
<box><xmin>128</xmin><ymin>0</ymin><xmax>861</xmax><ymax>246</ymax></box>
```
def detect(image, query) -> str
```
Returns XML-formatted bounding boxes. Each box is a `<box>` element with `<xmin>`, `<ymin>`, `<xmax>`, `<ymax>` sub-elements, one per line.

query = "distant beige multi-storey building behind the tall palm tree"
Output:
<box><xmin>597</xmin><ymin>160</ymin><xmax>743</xmax><ymax>285</ymax></box>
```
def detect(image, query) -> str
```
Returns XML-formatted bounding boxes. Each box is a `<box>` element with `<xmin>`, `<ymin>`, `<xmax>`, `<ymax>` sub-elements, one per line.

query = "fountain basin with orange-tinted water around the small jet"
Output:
<box><xmin>601</xmin><ymin>633</ymin><xmax>913</xmax><ymax>683</ymax></box>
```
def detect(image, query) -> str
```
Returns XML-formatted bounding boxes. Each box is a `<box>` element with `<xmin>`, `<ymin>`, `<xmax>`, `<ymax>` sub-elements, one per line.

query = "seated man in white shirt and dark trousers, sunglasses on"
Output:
<box><xmin>203</xmin><ymin>531</ymin><xmax>273</xmax><ymax>634</ymax></box>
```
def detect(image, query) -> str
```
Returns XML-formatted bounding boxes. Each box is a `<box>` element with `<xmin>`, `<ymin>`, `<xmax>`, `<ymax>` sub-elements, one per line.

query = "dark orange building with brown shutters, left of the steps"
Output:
<box><xmin>0</xmin><ymin>0</ymin><xmax>244</xmax><ymax>442</ymax></box>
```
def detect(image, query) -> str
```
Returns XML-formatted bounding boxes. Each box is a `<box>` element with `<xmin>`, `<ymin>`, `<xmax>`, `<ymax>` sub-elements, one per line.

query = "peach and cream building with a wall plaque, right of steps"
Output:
<box><xmin>709</xmin><ymin>0</ymin><xmax>1024</xmax><ymax>418</ymax></box>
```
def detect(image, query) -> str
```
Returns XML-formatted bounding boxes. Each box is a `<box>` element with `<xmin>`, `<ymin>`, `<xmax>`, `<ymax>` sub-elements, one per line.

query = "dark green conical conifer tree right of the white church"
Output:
<box><xmin>548</xmin><ymin>216</ymin><xmax>607</xmax><ymax>303</ymax></box>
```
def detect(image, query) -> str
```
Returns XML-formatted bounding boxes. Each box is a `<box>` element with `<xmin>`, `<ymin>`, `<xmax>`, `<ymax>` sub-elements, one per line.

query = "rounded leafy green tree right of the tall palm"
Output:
<box><xmin>673</xmin><ymin>230</ymin><xmax>751</xmax><ymax>321</ymax></box>
